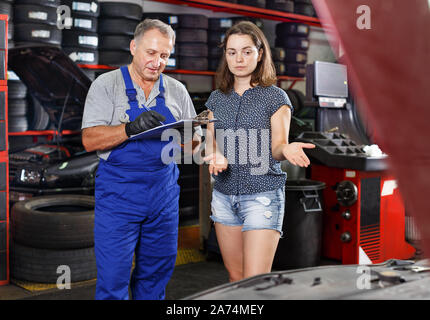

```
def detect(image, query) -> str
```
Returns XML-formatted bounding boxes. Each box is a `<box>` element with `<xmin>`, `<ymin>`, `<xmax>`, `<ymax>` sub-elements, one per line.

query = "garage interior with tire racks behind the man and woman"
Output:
<box><xmin>0</xmin><ymin>0</ymin><xmax>424</xmax><ymax>300</ymax></box>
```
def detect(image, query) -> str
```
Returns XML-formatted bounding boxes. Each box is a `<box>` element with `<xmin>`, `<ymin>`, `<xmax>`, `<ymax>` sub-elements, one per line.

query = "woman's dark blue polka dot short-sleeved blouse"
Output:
<box><xmin>206</xmin><ymin>86</ymin><xmax>292</xmax><ymax>195</ymax></box>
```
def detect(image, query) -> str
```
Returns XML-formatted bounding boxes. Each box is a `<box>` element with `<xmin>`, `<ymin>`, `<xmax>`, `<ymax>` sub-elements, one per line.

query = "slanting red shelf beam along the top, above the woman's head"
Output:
<box><xmin>148</xmin><ymin>0</ymin><xmax>321</xmax><ymax>27</ymax></box>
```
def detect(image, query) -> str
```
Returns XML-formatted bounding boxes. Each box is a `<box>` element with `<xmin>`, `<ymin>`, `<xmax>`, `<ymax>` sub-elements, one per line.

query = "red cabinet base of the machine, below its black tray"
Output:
<box><xmin>311</xmin><ymin>165</ymin><xmax>415</xmax><ymax>264</ymax></box>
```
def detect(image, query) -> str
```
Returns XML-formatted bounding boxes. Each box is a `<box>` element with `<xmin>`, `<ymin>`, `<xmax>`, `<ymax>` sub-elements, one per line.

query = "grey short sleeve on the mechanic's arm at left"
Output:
<box><xmin>82</xmin><ymin>76</ymin><xmax>114</xmax><ymax>129</ymax></box>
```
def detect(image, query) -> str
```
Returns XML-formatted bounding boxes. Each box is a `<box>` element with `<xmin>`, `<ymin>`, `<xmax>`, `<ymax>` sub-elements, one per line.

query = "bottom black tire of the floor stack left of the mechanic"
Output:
<box><xmin>10</xmin><ymin>241</ymin><xmax>97</xmax><ymax>283</ymax></box>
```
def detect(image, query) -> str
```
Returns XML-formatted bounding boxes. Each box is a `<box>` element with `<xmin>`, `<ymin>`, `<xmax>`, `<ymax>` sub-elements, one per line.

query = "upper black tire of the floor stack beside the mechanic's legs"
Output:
<box><xmin>11</xmin><ymin>195</ymin><xmax>95</xmax><ymax>250</ymax></box>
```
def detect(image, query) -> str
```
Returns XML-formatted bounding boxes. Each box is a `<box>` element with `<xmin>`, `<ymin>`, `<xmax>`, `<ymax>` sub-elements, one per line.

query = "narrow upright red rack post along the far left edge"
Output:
<box><xmin>0</xmin><ymin>15</ymin><xmax>9</xmax><ymax>286</ymax></box>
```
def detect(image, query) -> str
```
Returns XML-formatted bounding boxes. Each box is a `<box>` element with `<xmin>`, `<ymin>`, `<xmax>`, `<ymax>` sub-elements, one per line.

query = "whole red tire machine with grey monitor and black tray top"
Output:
<box><xmin>297</xmin><ymin>61</ymin><xmax>415</xmax><ymax>264</ymax></box>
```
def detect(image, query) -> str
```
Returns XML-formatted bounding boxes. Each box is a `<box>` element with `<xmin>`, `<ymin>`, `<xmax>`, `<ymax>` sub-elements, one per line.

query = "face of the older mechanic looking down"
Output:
<box><xmin>130</xmin><ymin>29</ymin><xmax>173</xmax><ymax>81</ymax></box>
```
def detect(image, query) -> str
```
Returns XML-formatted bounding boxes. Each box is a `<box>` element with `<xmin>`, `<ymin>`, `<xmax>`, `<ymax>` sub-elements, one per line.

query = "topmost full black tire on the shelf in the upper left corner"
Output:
<box><xmin>13</xmin><ymin>4</ymin><xmax>57</xmax><ymax>26</ymax></box>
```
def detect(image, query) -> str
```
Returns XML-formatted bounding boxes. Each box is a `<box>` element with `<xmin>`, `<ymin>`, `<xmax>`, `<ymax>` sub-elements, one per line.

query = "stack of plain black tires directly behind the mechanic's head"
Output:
<box><xmin>98</xmin><ymin>2</ymin><xmax>142</xmax><ymax>67</ymax></box>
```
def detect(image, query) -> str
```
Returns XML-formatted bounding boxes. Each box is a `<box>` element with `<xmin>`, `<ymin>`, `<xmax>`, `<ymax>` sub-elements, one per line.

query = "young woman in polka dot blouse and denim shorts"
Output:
<box><xmin>204</xmin><ymin>21</ymin><xmax>315</xmax><ymax>281</ymax></box>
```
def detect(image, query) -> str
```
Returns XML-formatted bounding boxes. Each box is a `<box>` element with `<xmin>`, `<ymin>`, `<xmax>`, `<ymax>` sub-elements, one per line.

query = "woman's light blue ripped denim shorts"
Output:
<box><xmin>210</xmin><ymin>187</ymin><xmax>285</xmax><ymax>236</ymax></box>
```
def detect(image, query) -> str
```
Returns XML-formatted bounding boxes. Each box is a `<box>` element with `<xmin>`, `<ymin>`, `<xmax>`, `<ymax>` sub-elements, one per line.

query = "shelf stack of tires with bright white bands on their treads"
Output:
<box><xmin>62</xmin><ymin>0</ymin><xmax>100</xmax><ymax>80</ymax></box>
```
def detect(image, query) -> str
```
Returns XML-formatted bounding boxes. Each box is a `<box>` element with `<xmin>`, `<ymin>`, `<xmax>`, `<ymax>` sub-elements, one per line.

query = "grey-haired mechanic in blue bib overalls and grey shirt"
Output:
<box><xmin>82</xmin><ymin>19</ymin><xmax>196</xmax><ymax>300</ymax></box>
